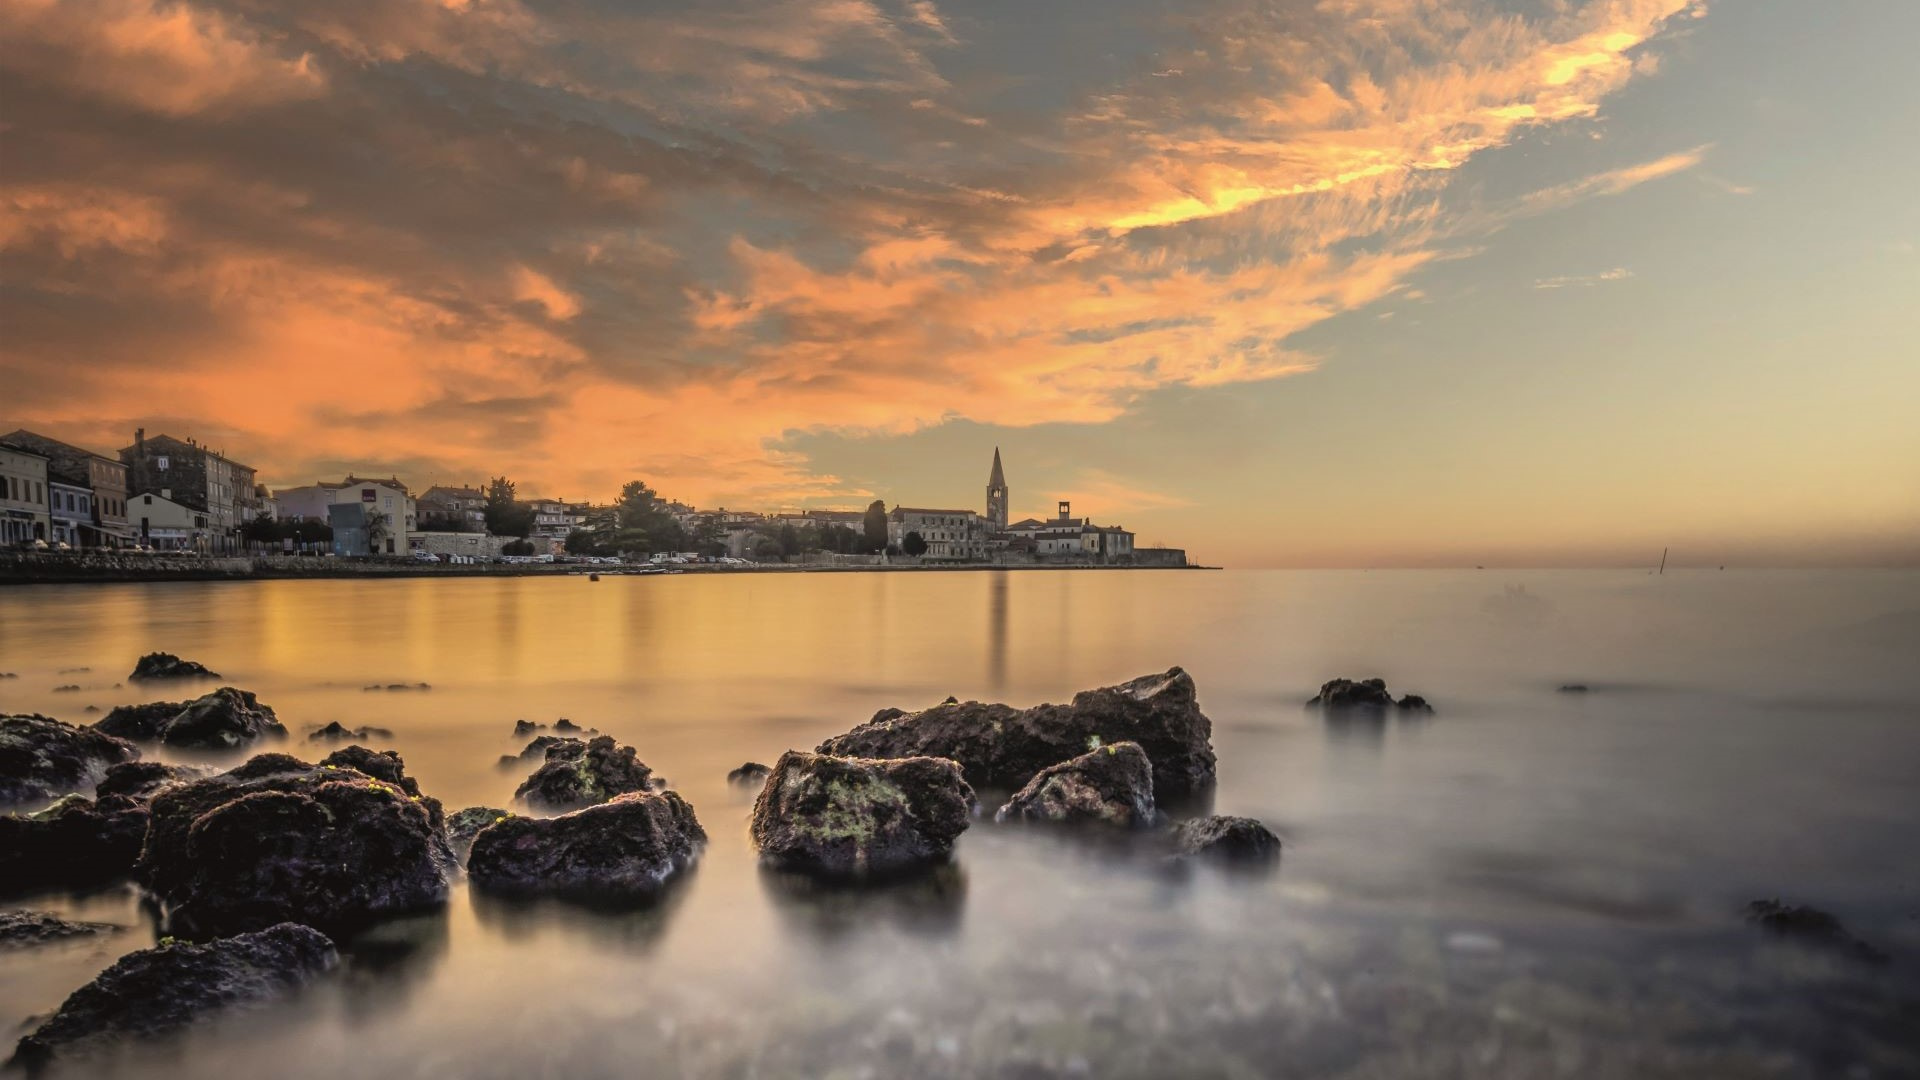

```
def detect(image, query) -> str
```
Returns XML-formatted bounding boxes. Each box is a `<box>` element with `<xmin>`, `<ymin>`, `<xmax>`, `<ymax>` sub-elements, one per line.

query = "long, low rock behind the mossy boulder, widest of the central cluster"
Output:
<box><xmin>818</xmin><ymin>667</ymin><xmax>1213</xmax><ymax>796</ymax></box>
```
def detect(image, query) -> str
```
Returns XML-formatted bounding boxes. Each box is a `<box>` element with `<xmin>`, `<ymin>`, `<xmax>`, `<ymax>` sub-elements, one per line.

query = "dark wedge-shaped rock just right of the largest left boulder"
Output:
<box><xmin>467</xmin><ymin>792</ymin><xmax>707</xmax><ymax>899</ymax></box>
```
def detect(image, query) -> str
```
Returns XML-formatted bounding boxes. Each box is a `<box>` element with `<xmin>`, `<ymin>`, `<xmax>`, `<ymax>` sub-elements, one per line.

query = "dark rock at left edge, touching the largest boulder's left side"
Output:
<box><xmin>0</xmin><ymin>796</ymin><xmax>148</xmax><ymax>892</ymax></box>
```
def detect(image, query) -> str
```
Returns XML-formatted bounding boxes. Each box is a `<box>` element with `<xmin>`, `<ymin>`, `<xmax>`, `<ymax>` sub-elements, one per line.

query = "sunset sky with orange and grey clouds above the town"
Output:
<box><xmin>0</xmin><ymin>0</ymin><xmax>1920</xmax><ymax>567</ymax></box>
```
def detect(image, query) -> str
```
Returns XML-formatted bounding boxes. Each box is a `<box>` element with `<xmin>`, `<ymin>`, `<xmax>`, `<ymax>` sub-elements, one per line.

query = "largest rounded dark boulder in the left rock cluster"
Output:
<box><xmin>140</xmin><ymin>748</ymin><xmax>453</xmax><ymax>936</ymax></box>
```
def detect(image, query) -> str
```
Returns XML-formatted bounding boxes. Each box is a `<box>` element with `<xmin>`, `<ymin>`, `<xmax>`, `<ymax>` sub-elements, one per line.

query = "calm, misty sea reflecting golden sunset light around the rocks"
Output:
<box><xmin>0</xmin><ymin>571</ymin><xmax>1920</xmax><ymax>1080</ymax></box>
